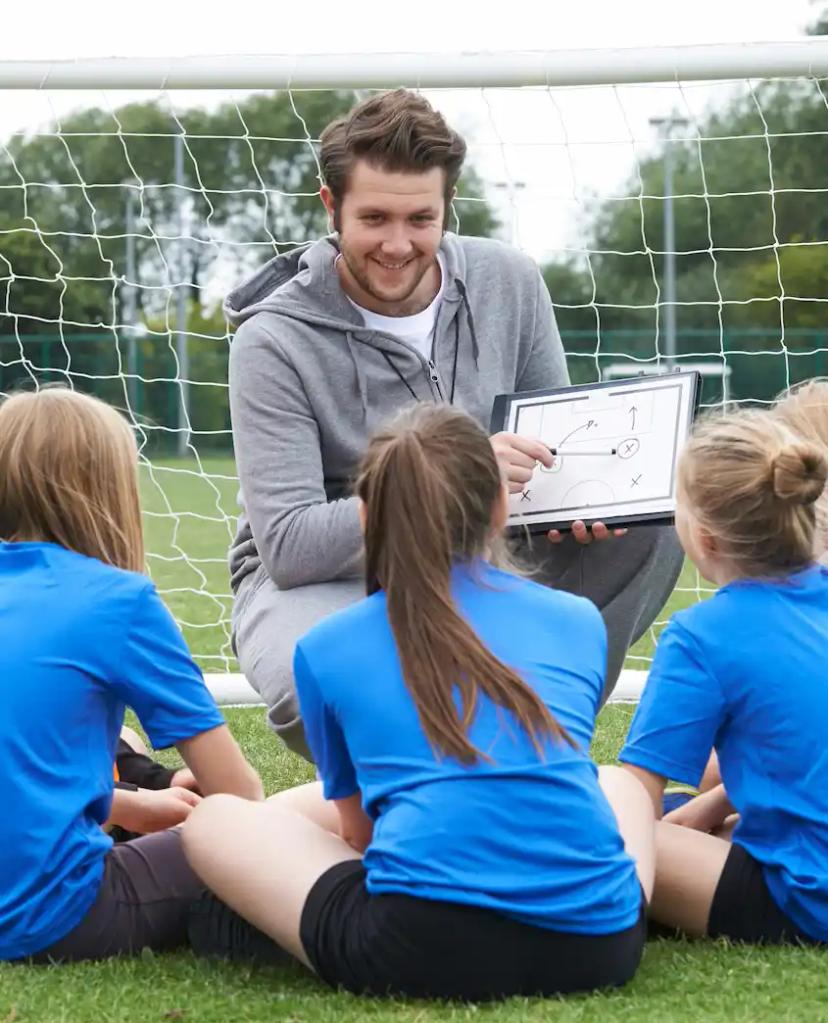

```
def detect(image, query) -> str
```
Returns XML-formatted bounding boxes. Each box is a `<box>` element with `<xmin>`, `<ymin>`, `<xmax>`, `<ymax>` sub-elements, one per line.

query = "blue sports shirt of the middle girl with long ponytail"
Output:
<box><xmin>295</xmin><ymin>562</ymin><xmax>641</xmax><ymax>934</ymax></box>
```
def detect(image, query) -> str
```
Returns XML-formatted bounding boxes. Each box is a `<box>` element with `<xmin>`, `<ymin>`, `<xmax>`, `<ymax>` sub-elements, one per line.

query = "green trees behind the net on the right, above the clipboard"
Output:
<box><xmin>544</xmin><ymin>81</ymin><xmax>828</xmax><ymax>398</ymax></box>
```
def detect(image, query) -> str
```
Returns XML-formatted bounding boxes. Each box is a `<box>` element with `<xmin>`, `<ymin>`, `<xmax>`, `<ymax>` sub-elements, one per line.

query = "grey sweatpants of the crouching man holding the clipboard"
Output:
<box><xmin>232</xmin><ymin>526</ymin><xmax>684</xmax><ymax>759</ymax></box>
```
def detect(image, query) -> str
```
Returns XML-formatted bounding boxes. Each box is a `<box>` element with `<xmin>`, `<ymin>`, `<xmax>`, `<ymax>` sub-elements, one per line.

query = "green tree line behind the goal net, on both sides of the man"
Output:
<box><xmin>0</xmin><ymin>62</ymin><xmax>828</xmax><ymax>448</ymax></box>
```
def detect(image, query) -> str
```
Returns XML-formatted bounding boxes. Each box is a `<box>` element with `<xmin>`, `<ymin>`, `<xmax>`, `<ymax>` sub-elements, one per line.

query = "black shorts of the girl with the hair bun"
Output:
<box><xmin>707</xmin><ymin>842</ymin><xmax>823</xmax><ymax>945</ymax></box>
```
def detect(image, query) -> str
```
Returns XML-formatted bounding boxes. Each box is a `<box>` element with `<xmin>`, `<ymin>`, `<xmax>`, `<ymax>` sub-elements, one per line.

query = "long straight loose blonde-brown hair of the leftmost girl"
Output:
<box><xmin>0</xmin><ymin>387</ymin><xmax>143</xmax><ymax>572</ymax></box>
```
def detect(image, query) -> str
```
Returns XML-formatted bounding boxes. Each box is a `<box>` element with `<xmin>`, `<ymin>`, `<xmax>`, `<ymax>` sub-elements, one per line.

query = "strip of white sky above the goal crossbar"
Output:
<box><xmin>0</xmin><ymin>0</ymin><xmax>814</xmax><ymax>60</ymax></box>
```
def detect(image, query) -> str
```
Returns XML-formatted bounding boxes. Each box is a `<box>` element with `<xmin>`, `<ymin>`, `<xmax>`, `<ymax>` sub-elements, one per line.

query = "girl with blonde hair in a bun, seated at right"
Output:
<box><xmin>620</xmin><ymin>411</ymin><xmax>828</xmax><ymax>943</ymax></box>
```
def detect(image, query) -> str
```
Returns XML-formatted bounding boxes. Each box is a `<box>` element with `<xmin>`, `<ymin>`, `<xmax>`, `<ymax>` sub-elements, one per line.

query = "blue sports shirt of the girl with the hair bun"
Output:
<box><xmin>621</xmin><ymin>566</ymin><xmax>828</xmax><ymax>941</ymax></box>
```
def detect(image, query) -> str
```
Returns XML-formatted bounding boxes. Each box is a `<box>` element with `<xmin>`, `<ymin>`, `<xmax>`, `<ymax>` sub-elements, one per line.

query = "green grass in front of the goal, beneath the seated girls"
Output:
<box><xmin>0</xmin><ymin>706</ymin><xmax>828</xmax><ymax>1023</ymax></box>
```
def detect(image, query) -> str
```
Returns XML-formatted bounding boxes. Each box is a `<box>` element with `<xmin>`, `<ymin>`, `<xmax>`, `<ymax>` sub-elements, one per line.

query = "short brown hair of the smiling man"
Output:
<box><xmin>319</xmin><ymin>89</ymin><xmax>466</xmax><ymax>224</ymax></box>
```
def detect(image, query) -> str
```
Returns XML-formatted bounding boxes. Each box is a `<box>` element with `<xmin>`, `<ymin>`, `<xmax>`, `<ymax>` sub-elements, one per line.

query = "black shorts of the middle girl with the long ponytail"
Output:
<box><xmin>300</xmin><ymin>859</ymin><xmax>647</xmax><ymax>1002</ymax></box>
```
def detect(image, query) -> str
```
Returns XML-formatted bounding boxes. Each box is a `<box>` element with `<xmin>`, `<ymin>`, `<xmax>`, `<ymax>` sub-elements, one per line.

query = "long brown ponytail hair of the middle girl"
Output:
<box><xmin>356</xmin><ymin>403</ymin><xmax>572</xmax><ymax>764</ymax></box>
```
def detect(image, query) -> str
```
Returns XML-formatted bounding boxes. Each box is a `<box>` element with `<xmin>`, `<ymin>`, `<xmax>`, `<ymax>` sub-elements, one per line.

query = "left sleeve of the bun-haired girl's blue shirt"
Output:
<box><xmin>619</xmin><ymin>621</ymin><xmax>727</xmax><ymax>785</ymax></box>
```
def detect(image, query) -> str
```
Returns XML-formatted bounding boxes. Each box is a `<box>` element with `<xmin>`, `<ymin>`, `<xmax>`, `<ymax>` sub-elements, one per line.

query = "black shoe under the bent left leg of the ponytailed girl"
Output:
<box><xmin>187</xmin><ymin>888</ymin><xmax>291</xmax><ymax>966</ymax></box>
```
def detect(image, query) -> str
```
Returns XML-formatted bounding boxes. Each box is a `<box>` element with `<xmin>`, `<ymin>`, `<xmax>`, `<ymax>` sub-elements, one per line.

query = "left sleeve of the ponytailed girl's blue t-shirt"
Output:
<box><xmin>294</xmin><ymin>644</ymin><xmax>359</xmax><ymax>799</ymax></box>
